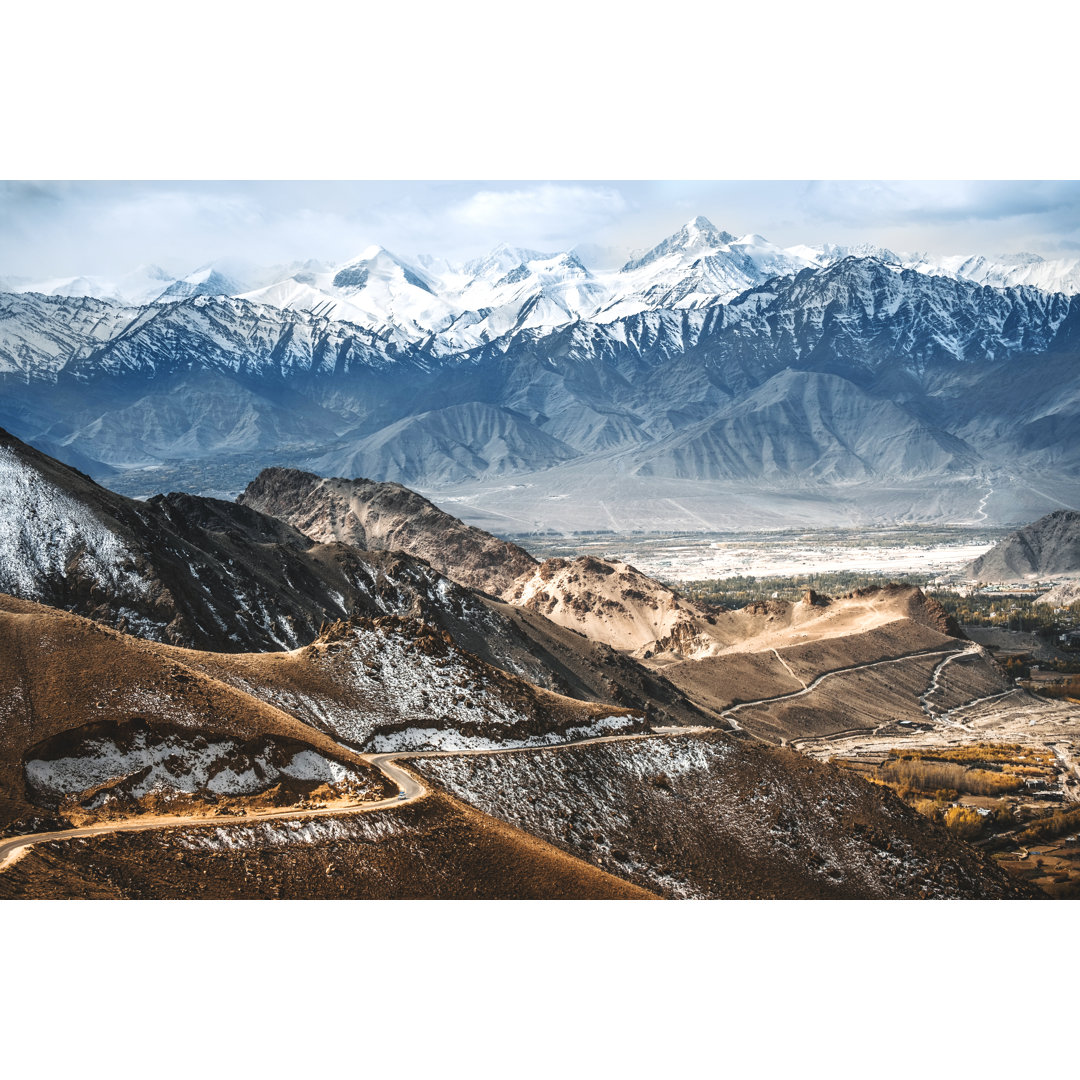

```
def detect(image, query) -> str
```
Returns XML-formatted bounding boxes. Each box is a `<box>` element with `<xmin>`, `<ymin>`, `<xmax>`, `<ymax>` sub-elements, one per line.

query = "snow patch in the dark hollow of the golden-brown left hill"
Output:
<box><xmin>26</xmin><ymin>731</ymin><xmax>361</xmax><ymax>799</ymax></box>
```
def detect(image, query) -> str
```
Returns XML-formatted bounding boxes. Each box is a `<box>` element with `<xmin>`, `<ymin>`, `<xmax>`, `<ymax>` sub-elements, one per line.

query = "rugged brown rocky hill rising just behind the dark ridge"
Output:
<box><xmin>238</xmin><ymin>469</ymin><xmax>536</xmax><ymax>595</ymax></box>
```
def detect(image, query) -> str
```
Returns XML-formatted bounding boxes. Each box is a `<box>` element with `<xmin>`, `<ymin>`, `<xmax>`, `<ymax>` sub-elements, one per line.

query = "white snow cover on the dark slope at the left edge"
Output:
<box><xmin>0</xmin><ymin>447</ymin><xmax>147</xmax><ymax>600</ymax></box>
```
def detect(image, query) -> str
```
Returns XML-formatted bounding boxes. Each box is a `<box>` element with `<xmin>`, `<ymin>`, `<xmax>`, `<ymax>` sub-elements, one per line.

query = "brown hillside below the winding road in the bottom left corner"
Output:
<box><xmin>0</xmin><ymin>793</ymin><xmax>656</xmax><ymax>900</ymax></box>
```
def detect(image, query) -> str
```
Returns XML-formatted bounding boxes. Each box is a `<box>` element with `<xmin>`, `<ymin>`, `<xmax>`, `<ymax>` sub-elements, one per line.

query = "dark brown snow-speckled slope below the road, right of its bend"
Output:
<box><xmin>418</xmin><ymin>734</ymin><xmax>1029</xmax><ymax>899</ymax></box>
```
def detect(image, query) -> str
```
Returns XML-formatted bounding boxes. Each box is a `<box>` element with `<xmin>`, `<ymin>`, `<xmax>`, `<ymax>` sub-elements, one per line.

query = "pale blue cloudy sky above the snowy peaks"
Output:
<box><xmin>0</xmin><ymin>180</ymin><xmax>1080</xmax><ymax>279</ymax></box>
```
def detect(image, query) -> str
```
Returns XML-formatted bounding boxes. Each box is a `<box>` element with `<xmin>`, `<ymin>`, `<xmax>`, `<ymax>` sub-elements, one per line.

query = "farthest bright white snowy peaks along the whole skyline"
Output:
<box><xmin>6</xmin><ymin>216</ymin><xmax>1080</xmax><ymax>347</ymax></box>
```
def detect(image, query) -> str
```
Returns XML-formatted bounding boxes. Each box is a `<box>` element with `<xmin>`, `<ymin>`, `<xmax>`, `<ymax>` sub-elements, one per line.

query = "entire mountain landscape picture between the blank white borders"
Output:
<box><xmin>0</xmin><ymin>181</ymin><xmax>1080</xmax><ymax>900</ymax></box>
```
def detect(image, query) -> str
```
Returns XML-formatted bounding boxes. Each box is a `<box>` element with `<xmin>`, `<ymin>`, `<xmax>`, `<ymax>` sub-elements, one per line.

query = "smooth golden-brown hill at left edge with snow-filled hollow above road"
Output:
<box><xmin>0</xmin><ymin>595</ymin><xmax>393</xmax><ymax>833</ymax></box>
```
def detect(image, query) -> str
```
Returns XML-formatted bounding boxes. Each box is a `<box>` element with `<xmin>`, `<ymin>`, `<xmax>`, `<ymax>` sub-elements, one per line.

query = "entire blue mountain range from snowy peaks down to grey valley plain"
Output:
<box><xmin>0</xmin><ymin>217</ymin><xmax>1080</xmax><ymax>532</ymax></box>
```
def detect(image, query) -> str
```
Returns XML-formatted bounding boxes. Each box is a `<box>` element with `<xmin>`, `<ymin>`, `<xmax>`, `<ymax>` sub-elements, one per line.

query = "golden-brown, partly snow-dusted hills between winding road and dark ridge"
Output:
<box><xmin>0</xmin><ymin>595</ymin><xmax>647</xmax><ymax>832</ymax></box>
